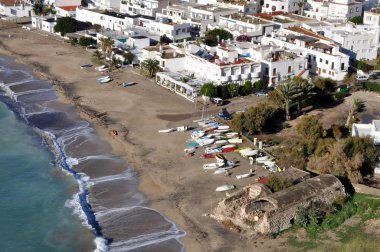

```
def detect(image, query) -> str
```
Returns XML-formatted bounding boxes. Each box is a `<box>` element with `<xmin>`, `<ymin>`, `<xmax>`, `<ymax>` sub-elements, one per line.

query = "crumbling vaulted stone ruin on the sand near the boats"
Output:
<box><xmin>211</xmin><ymin>174</ymin><xmax>345</xmax><ymax>234</ymax></box>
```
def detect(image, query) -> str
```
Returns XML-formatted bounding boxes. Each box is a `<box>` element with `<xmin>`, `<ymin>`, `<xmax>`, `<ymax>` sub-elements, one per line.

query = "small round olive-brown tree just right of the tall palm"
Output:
<box><xmin>296</xmin><ymin>116</ymin><xmax>323</xmax><ymax>140</ymax></box>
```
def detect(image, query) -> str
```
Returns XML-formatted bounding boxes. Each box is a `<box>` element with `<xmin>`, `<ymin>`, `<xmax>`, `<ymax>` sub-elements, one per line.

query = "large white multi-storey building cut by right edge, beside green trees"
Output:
<box><xmin>323</xmin><ymin>24</ymin><xmax>379</xmax><ymax>60</ymax></box>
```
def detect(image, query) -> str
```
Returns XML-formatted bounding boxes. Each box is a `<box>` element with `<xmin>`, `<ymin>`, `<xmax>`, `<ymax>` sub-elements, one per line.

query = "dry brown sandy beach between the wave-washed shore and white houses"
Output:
<box><xmin>0</xmin><ymin>24</ymin><xmax>290</xmax><ymax>251</ymax></box>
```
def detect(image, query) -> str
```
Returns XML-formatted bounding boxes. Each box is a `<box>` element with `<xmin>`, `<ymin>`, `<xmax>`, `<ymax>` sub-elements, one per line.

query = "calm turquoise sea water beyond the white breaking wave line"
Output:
<box><xmin>0</xmin><ymin>102</ymin><xmax>95</xmax><ymax>252</ymax></box>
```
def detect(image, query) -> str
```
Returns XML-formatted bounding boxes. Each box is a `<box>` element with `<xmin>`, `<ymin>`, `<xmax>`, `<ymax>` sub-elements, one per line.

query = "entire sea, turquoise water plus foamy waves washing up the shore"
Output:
<box><xmin>0</xmin><ymin>57</ymin><xmax>186</xmax><ymax>252</ymax></box>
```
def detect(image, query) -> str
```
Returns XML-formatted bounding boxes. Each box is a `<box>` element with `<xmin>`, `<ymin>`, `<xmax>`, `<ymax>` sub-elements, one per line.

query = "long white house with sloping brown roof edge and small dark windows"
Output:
<box><xmin>261</xmin><ymin>27</ymin><xmax>349</xmax><ymax>81</ymax></box>
